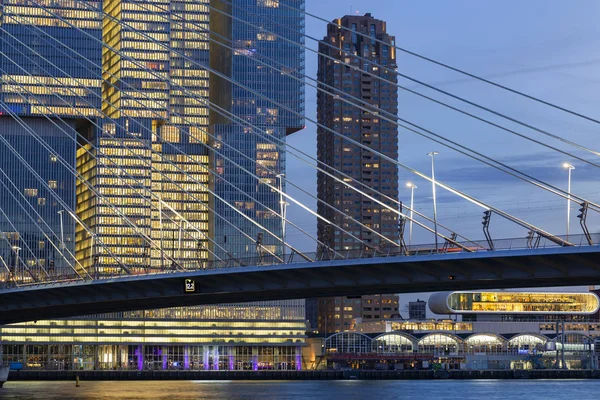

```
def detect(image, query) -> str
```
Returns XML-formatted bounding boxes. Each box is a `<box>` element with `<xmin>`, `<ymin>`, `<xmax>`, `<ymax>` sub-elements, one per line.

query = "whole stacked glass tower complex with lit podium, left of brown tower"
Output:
<box><xmin>0</xmin><ymin>0</ymin><xmax>305</xmax><ymax>370</ymax></box>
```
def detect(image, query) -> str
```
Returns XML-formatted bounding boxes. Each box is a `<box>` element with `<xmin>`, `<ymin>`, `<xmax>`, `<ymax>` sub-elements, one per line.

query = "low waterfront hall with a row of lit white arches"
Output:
<box><xmin>304</xmin><ymin>331</ymin><xmax>598</xmax><ymax>370</ymax></box>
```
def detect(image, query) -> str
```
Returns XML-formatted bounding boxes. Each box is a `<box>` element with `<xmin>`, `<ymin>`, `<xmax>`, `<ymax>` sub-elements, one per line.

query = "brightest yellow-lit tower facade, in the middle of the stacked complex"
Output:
<box><xmin>77</xmin><ymin>0</ymin><xmax>210</xmax><ymax>275</ymax></box>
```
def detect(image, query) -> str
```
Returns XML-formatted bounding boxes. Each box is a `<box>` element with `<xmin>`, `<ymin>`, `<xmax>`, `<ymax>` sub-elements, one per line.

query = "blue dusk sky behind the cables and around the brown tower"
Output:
<box><xmin>288</xmin><ymin>0</ymin><xmax>600</xmax><ymax>314</ymax></box>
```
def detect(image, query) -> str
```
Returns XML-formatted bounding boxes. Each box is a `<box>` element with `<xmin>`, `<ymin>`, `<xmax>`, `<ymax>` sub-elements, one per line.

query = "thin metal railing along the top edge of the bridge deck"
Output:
<box><xmin>0</xmin><ymin>233</ymin><xmax>600</xmax><ymax>289</ymax></box>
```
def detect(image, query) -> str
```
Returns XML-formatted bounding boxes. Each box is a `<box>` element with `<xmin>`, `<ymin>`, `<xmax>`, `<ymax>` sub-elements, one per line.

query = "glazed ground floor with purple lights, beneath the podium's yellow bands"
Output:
<box><xmin>2</xmin><ymin>344</ymin><xmax>302</xmax><ymax>371</ymax></box>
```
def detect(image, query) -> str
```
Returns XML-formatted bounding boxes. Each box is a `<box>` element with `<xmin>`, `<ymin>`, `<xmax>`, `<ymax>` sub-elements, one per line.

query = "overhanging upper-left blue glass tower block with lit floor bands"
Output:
<box><xmin>0</xmin><ymin>0</ymin><xmax>102</xmax><ymax>118</ymax></box>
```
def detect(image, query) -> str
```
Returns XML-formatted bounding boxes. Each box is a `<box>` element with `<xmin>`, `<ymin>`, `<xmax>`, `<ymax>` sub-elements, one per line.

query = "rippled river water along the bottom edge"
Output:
<box><xmin>0</xmin><ymin>380</ymin><xmax>600</xmax><ymax>400</ymax></box>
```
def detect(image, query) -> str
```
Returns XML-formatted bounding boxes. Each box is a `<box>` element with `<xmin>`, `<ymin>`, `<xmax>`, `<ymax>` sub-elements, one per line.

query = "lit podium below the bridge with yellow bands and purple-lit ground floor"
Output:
<box><xmin>0</xmin><ymin>303</ymin><xmax>306</xmax><ymax>371</ymax></box>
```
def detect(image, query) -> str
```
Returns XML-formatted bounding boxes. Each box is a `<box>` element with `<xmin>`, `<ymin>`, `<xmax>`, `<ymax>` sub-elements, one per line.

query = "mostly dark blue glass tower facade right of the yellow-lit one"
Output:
<box><xmin>214</xmin><ymin>0</ymin><xmax>305</xmax><ymax>259</ymax></box>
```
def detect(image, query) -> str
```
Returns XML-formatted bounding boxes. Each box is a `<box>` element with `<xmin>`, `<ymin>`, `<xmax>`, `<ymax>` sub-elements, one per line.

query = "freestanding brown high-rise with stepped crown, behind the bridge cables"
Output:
<box><xmin>311</xmin><ymin>14</ymin><xmax>398</xmax><ymax>332</ymax></box>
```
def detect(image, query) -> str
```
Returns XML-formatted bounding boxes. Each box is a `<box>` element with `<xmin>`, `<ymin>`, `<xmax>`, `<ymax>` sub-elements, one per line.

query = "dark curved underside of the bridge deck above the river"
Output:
<box><xmin>0</xmin><ymin>246</ymin><xmax>600</xmax><ymax>324</ymax></box>
